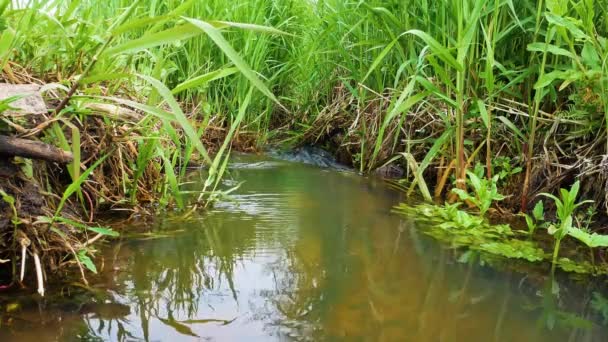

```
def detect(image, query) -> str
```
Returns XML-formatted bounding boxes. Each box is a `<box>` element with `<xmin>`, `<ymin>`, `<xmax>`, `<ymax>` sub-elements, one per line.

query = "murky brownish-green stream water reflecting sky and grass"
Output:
<box><xmin>0</xmin><ymin>156</ymin><xmax>607</xmax><ymax>341</ymax></box>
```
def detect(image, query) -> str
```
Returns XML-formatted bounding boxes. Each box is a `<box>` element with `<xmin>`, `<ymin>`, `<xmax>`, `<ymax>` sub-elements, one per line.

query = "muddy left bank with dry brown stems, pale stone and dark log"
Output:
<box><xmin>0</xmin><ymin>80</ymin><xmax>262</xmax><ymax>294</ymax></box>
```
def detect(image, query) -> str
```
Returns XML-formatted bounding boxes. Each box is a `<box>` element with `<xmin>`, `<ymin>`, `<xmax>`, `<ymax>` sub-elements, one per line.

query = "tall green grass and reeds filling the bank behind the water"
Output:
<box><xmin>0</xmin><ymin>0</ymin><xmax>608</xmax><ymax>209</ymax></box>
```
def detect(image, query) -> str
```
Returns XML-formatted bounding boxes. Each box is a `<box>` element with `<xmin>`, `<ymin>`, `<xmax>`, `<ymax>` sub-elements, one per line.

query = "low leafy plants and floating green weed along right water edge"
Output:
<box><xmin>396</xmin><ymin>179</ymin><xmax>608</xmax><ymax>275</ymax></box>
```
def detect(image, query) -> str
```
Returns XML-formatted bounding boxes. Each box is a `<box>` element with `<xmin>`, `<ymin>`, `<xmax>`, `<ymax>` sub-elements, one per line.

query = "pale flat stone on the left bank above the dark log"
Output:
<box><xmin>0</xmin><ymin>83</ymin><xmax>48</xmax><ymax>114</ymax></box>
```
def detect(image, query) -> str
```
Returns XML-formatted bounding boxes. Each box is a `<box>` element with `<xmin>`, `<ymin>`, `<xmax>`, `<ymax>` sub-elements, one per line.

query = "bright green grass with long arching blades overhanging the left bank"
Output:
<box><xmin>1</xmin><ymin>1</ymin><xmax>292</xmax><ymax>208</ymax></box>
